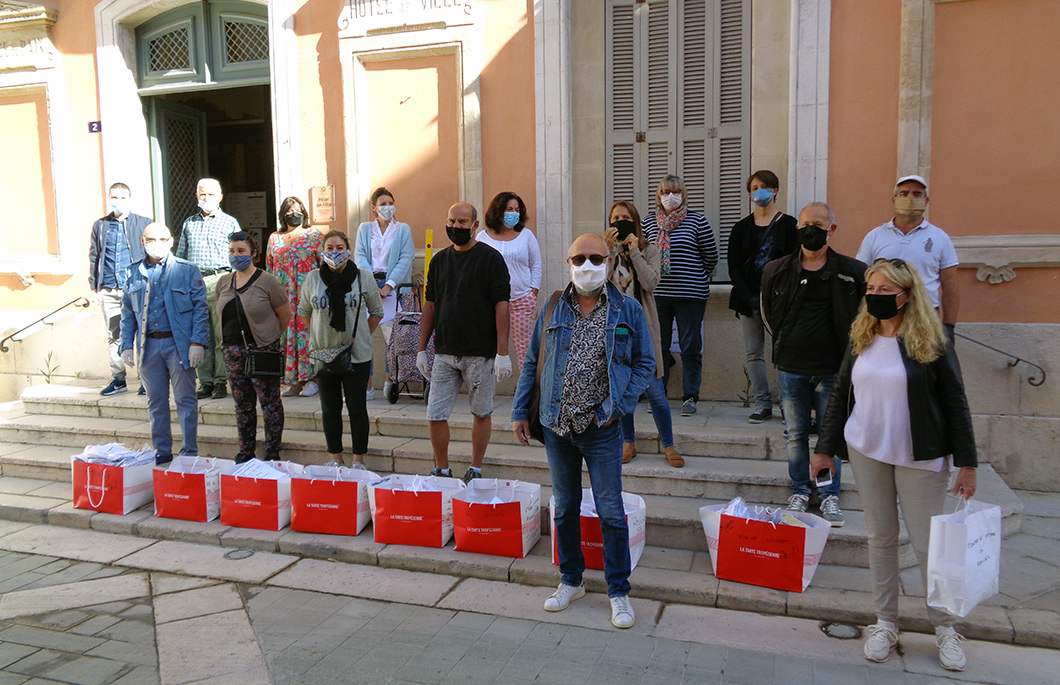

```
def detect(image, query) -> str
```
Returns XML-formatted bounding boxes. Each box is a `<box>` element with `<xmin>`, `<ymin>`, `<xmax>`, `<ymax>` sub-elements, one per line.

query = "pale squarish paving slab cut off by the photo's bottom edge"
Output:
<box><xmin>156</xmin><ymin>611</ymin><xmax>269</xmax><ymax>683</ymax></box>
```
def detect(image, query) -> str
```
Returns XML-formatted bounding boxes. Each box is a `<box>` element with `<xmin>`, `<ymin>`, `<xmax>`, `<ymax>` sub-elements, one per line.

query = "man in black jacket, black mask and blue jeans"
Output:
<box><xmin>762</xmin><ymin>203</ymin><xmax>866</xmax><ymax>527</ymax></box>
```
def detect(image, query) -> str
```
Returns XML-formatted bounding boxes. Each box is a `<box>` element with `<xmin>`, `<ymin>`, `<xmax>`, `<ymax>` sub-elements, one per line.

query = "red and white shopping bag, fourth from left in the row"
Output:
<box><xmin>290</xmin><ymin>467</ymin><xmax>378</xmax><ymax>535</ymax></box>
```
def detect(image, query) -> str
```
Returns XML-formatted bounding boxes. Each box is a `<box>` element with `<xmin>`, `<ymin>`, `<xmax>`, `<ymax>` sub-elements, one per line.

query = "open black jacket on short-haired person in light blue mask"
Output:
<box><xmin>728</xmin><ymin>213</ymin><xmax>798</xmax><ymax>316</ymax></box>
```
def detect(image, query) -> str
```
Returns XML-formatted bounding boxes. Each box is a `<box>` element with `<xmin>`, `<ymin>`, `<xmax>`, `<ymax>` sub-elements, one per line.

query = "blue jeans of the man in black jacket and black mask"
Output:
<box><xmin>777</xmin><ymin>370</ymin><xmax>841</xmax><ymax>497</ymax></box>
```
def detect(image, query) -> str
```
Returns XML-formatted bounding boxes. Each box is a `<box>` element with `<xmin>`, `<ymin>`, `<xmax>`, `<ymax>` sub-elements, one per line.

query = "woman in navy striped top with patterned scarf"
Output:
<box><xmin>643</xmin><ymin>175</ymin><xmax>718</xmax><ymax>417</ymax></box>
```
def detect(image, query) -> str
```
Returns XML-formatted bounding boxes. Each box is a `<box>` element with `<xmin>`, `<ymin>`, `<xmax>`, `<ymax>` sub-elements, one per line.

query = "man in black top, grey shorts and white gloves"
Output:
<box><xmin>416</xmin><ymin>203</ymin><xmax>512</xmax><ymax>482</ymax></box>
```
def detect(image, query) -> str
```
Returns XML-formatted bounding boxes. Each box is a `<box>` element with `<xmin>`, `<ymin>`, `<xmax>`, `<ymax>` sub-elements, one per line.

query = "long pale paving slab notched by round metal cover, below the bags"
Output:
<box><xmin>113</xmin><ymin>541</ymin><xmax>298</xmax><ymax>583</ymax></box>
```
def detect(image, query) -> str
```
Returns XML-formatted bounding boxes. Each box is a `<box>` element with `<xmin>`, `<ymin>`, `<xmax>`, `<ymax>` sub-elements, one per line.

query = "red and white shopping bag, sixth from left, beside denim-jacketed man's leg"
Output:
<box><xmin>453</xmin><ymin>478</ymin><xmax>541</xmax><ymax>559</ymax></box>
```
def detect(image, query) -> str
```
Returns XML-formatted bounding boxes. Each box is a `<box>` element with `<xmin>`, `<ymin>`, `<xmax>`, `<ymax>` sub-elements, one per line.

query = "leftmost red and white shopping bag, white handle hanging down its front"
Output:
<box><xmin>72</xmin><ymin>457</ymin><xmax>155</xmax><ymax>515</ymax></box>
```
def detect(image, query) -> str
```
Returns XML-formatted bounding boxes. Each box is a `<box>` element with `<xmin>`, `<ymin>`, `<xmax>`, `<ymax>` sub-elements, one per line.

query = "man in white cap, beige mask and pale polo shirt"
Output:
<box><xmin>858</xmin><ymin>175</ymin><xmax>960</xmax><ymax>338</ymax></box>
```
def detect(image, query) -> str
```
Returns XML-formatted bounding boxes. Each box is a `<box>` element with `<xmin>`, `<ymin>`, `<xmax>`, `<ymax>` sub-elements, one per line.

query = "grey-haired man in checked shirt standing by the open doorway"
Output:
<box><xmin>173</xmin><ymin>178</ymin><xmax>242</xmax><ymax>400</ymax></box>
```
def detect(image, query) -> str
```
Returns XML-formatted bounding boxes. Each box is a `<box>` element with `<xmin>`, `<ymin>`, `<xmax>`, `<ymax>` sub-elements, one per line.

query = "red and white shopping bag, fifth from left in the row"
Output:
<box><xmin>368</xmin><ymin>474</ymin><xmax>464</xmax><ymax>547</ymax></box>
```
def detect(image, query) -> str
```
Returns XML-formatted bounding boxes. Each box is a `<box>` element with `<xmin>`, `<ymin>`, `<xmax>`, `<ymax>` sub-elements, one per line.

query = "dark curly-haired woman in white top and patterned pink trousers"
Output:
<box><xmin>477</xmin><ymin>191</ymin><xmax>541</xmax><ymax>369</ymax></box>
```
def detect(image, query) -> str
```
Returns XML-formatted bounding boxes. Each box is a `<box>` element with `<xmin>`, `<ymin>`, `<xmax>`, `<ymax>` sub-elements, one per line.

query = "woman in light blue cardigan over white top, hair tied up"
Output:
<box><xmin>354</xmin><ymin>186</ymin><xmax>416</xmax><ymax>400</ymax></box>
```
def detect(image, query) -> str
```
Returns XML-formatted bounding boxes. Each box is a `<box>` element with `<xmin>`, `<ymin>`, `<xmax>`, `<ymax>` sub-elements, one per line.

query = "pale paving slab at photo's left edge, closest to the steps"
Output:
<box><xmin>0</xmin><ymin>526</ymin><xmax>158</xmax><ymax>564</ymax></box>
